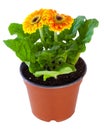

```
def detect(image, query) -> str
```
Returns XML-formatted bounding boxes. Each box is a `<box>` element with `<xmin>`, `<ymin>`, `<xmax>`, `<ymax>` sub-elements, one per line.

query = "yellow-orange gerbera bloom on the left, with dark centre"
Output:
<box><xmin>23</xmin><ymin>9</ymin><xmax>44</xmax><ymax>34</ymax></box>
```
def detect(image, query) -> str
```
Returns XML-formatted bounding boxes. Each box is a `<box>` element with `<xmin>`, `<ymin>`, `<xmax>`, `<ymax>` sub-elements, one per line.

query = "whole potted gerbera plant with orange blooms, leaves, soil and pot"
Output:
<box><xmin>4</xmin><ymin>9</ymin><xmax>98</xmax><ymax>121</ymax></box>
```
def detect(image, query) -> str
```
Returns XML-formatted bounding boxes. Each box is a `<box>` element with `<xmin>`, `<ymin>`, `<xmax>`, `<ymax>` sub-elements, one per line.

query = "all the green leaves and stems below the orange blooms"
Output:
<box><xmin>4</xmin><ymin>8</ymin><xmax>98</xmax><ymax>81</ymax></box>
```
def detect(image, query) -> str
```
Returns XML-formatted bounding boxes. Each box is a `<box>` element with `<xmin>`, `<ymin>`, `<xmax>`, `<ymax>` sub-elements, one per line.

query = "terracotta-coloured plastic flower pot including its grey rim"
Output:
<box><xmin>20</xmin><ymin>58</ymin><xmax>86</xmax><ymax>121</ymax></box>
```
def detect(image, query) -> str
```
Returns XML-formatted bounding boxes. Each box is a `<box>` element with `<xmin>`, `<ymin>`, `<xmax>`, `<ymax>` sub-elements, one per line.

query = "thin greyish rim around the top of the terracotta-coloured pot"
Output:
<box><xmin>20</xmin><ymin>58</ymin><xmax>87</xmax><ymax>89</ymax></box>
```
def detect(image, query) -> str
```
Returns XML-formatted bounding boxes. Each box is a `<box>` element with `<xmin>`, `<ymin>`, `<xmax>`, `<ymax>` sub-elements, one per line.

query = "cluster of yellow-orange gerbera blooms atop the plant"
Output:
<box><xmin>23</xmin><ymin>9</ymin><xmax>74</xmax><ymax>34</ymax></box>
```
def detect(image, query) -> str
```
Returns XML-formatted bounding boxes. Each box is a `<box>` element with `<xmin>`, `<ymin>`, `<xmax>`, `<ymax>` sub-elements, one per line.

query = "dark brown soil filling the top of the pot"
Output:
<box><xmin>20</xmin><ymin>58</ymin><xmax>86</xmax><ymax>87</ymax></box>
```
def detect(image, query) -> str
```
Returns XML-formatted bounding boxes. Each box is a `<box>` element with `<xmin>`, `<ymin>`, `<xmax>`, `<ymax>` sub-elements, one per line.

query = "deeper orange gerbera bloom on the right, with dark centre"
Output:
<box><xmin>49</xmin><ymin>14</ymin><xmax>74</xmax><ymax>32</ymax></box>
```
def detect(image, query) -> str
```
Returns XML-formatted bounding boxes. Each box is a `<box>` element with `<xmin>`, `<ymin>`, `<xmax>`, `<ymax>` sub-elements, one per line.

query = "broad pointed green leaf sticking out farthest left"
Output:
<box><xmin>4</xmin><ymin>38</ymin><xmax>35</xmax><ymax>62</ymax></box>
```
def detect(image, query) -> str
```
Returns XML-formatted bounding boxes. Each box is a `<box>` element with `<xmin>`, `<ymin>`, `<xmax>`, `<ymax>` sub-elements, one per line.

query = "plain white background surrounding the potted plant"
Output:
<box><xmin>0</xmin><ymin>0</ymin><xmax>104</xmax><ymax>130</ymax></box>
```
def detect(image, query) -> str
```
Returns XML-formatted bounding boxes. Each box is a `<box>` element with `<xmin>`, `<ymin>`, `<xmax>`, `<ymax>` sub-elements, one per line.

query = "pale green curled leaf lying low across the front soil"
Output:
<box><xmin>34</xmin><ymin>65</ymin><xmax>76</xmax><ymax>81</ymax></box>
